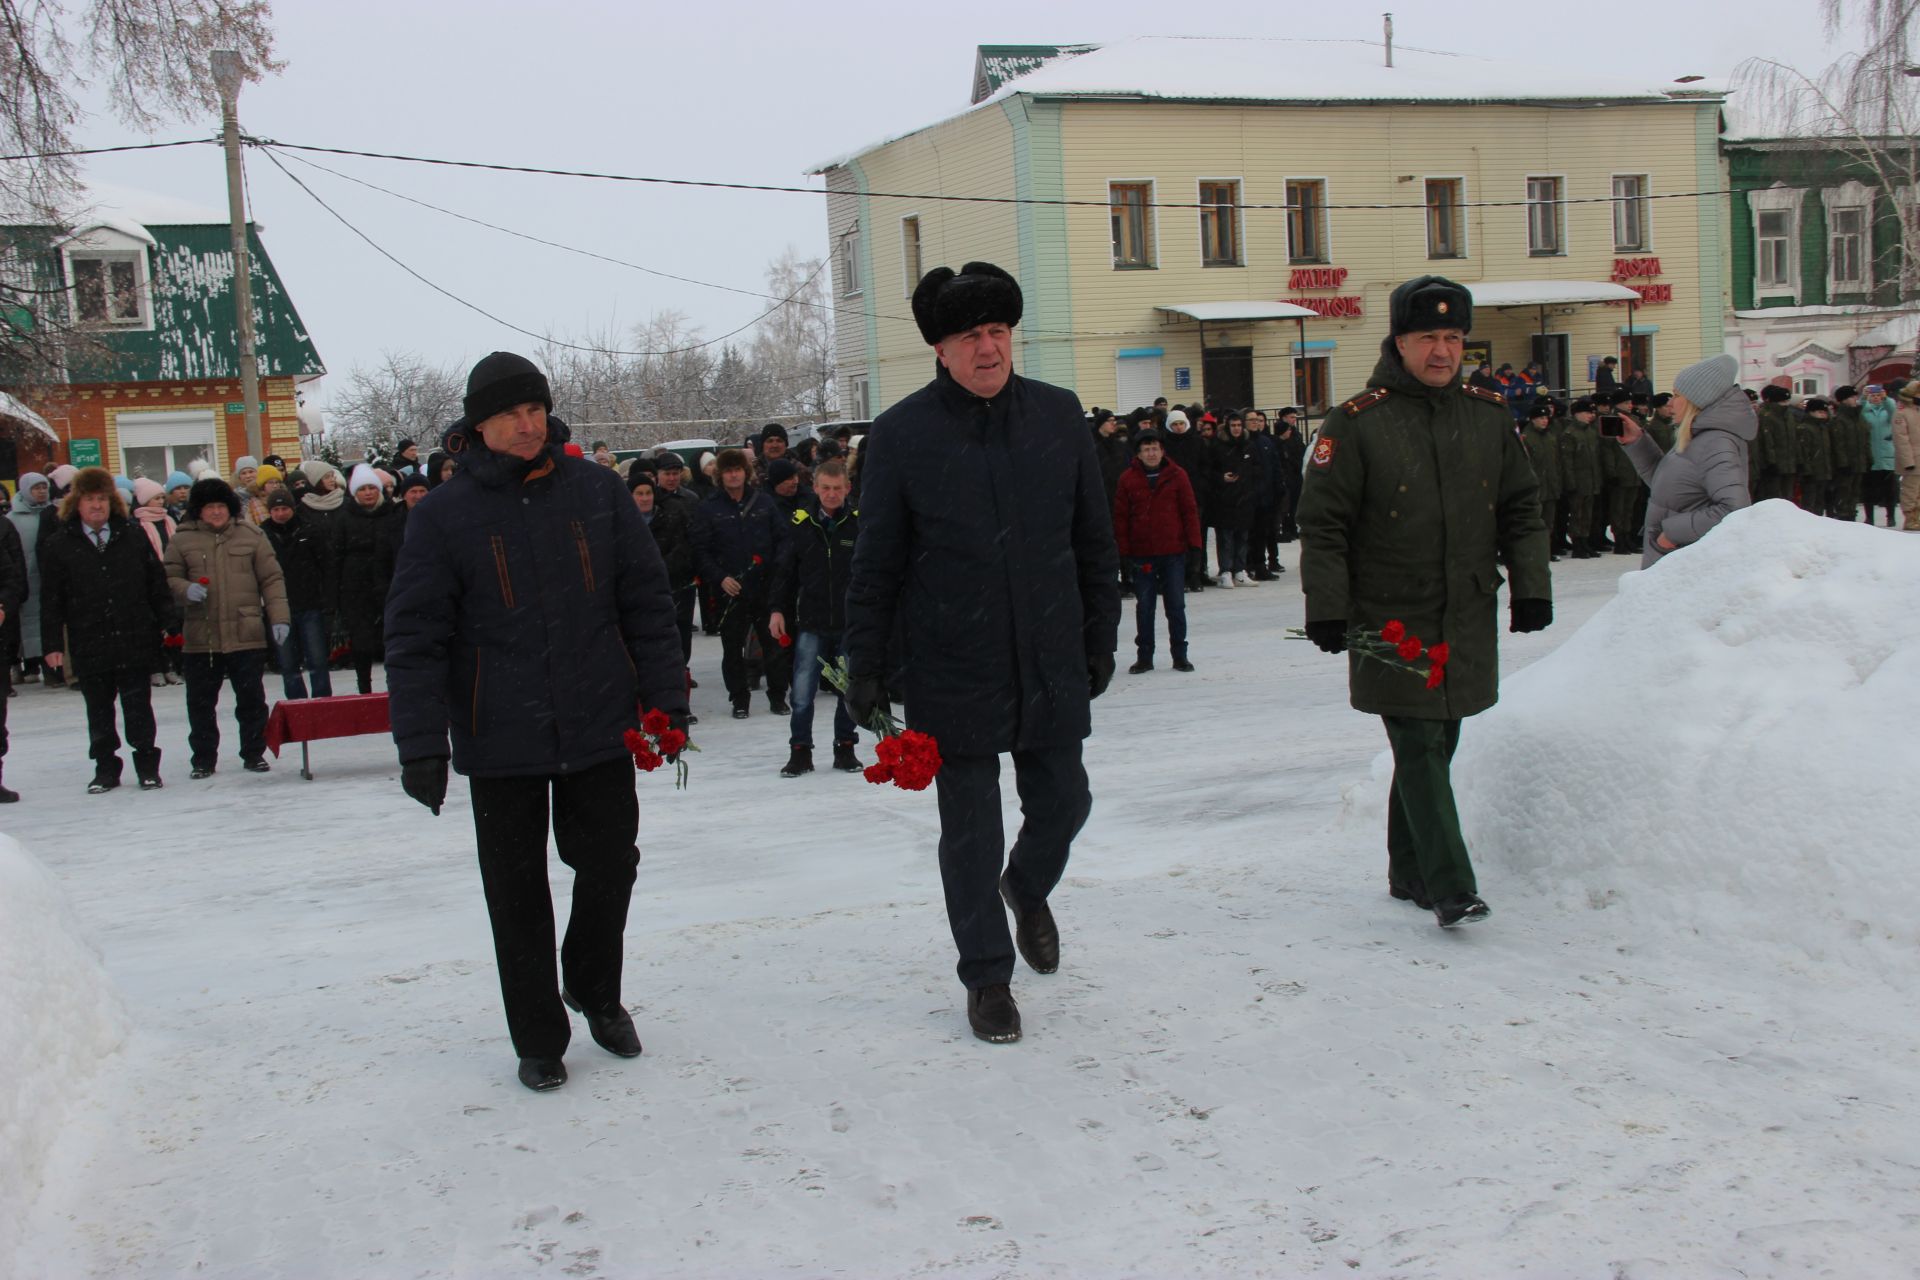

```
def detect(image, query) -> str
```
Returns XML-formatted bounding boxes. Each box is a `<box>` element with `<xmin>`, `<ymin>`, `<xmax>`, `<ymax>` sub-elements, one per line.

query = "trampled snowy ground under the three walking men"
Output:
<box><xmin>0</xmin><ymin>514</ymin><xmax>1920</xmax><ymax>1280</ymax></box>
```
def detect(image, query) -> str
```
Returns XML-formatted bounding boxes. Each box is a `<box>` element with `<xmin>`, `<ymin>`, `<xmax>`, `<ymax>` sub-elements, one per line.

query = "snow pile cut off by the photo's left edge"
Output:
<box><xmin>0</xmin><ymin>835</ymin><xmax>125</xmax><ymax>1268</ymax></box>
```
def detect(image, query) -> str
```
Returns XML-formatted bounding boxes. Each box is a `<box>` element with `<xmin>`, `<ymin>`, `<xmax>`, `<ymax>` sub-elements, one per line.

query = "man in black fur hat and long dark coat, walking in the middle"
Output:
<box><xmin>845</xmin><ymin>263</ymin><xmax>1119</xmax><ymax>1042</ymax></box>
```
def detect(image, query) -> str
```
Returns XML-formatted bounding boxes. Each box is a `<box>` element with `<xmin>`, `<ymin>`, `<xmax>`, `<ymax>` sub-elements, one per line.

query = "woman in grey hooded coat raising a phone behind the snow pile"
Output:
<box><xmin>1620</xmin><ymin>355</ymin><xmax>1759</xmax><ymax>568</ymax></box>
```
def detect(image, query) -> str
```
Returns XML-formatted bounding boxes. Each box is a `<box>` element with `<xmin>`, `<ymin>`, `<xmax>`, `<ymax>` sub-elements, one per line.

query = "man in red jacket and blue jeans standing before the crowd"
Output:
<box><xmin>1114</xmin><ymin>430</ymin><xmax>1206</xmax><ymax>676</ymax></box>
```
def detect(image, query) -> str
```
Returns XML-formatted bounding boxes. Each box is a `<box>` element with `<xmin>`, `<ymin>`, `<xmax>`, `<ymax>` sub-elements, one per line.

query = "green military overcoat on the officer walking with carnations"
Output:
<box><xmin>1298</xmin><ymin>355</ymin><xmax>1553</xmax><ymax>720</ymax></box>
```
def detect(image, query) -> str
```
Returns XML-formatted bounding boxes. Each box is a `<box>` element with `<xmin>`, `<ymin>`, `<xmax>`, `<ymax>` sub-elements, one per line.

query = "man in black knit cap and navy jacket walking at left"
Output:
<box><xmin>386</xmin><ymin>351</ymin><xmax>687</xmax><ymax>1090</ymax></box>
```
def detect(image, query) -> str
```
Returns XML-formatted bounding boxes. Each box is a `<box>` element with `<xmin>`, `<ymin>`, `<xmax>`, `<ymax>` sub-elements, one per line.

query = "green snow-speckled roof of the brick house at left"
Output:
<box><xmin>0</xmin><ymin>221</ymin><xmax>326</xmax><ymax>382</ymax></box>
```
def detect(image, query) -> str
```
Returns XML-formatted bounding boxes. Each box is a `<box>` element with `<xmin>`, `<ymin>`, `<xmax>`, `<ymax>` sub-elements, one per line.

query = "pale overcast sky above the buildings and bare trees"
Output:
<box><xmin>79</xmin><ymin>0</ymin><xmax>1837</xmax><ymax>412</ymax></box>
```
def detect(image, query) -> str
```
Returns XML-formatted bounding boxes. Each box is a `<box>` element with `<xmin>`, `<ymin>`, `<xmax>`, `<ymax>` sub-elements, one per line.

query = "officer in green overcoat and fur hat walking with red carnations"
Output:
<box><xmin>1300</xmin><ymin>276</ymin><xmax>1553</xmax><ymax>927</ymax></box>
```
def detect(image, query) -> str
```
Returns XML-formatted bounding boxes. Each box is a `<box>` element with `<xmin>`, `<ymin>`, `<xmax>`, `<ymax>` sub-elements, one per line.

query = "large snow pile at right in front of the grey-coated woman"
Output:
<box><xmin>1453</xmin><ymin>501</ymin><xmax>1920</xmax><ymax>981</ymax></box>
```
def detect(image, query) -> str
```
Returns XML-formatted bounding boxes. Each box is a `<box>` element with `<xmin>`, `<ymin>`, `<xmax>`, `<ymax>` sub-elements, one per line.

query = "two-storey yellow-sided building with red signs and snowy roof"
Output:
<box><xmin>820</xmin><ymin>38</ymin><xmax>1728</xmax><ymax>416</ymax></box>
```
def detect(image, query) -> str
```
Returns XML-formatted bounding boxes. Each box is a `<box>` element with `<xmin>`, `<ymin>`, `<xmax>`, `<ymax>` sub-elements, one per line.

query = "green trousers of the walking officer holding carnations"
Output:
<box><xmin>1380</xmin><ymin>716</ymin><xmax>1476</xmax><ymax>902</ymax></box>
